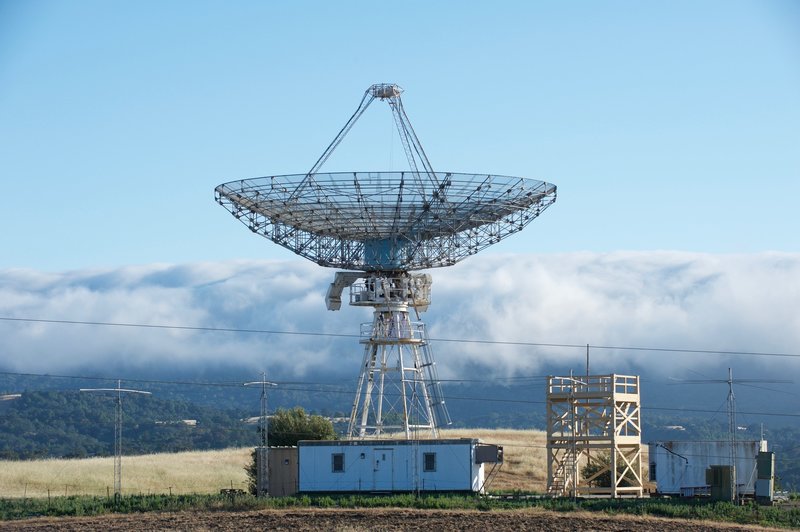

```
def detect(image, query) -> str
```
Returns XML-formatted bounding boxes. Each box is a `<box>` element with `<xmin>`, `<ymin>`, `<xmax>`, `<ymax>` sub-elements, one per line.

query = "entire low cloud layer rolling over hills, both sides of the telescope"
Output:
<box><xmin>0</xmin><ymin>252</ymin><xmax>800</xmax><ymax>378</ymax></box>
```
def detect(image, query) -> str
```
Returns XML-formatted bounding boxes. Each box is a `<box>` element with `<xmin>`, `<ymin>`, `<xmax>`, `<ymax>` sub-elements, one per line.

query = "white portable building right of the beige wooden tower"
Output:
<box><xmin>649</xmin><ymin>440</ymin><xmax>767</xmax><ymax>497</ymax></box>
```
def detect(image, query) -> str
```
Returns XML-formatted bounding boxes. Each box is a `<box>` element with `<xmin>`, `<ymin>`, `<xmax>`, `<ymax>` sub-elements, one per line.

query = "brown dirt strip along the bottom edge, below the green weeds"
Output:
<box><xmin>0</xmin><ymin>509</ymin><xmax>772</xmax><ymax>532</ymax></box>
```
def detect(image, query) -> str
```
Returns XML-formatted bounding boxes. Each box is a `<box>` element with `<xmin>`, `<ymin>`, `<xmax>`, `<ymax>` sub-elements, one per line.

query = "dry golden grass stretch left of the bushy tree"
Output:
<box><xmin>0</xmin><ymin>448</ymin><xmax>250</xmax><ymax>497</ymax></box>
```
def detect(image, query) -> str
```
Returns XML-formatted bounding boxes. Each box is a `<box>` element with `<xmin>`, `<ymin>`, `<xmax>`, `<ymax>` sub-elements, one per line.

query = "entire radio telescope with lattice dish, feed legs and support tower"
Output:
<box><xmin>215</xmin><ymin>83</ymin><xmax>556</xmax><ymax>438</ymax></box>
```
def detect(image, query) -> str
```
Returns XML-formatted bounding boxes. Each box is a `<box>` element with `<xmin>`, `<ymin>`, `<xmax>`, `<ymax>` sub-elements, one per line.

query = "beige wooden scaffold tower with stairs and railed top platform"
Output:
<box><xmin>547</xmin><ymin>375</ymin><xmax>642</xmax><ymax>497</ymax></box>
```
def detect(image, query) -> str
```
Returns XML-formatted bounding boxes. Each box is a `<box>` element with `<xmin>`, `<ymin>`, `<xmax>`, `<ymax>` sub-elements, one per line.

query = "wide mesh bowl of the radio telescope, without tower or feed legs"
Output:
<box><xmin>217</xmin><ymin>172</ymin><xmax>556</xmax><ymax>271</ymax></box>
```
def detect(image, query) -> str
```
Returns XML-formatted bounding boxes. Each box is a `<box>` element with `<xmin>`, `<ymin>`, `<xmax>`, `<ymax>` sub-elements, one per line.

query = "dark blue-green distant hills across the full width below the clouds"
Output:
<box><xmin>0</xmin><ymin>371</ymin><xmax>800</xmax><ymax>489</ymax></box>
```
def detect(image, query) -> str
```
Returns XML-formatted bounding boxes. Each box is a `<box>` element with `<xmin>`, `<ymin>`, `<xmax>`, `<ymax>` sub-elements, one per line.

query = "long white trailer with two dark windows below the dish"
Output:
<box><xmin>297</xmin><ymin>438</ymin><xmax>503</xmax><ymax>493</ymax></box>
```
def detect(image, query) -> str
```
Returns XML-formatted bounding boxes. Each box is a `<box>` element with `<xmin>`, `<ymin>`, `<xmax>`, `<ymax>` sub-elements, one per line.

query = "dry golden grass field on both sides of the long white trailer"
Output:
<box><xmin>0</xmin><ymin>429</ymin><xmax>600</xmax><ymax>498</ymax></box>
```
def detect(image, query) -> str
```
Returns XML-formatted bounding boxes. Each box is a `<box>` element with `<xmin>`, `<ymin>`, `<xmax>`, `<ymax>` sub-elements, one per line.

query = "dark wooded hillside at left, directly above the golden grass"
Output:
<box><xmin>0</xmin><ymin>391</ymin><xmax>258</xmax><ymax>459</ymax></box>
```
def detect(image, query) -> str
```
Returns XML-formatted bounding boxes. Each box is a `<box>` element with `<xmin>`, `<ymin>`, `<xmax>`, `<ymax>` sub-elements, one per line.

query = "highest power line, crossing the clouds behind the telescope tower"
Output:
<box><xmin>0</xmin><ymin>316</ymin><xmax>800</xmax><ymax>358</ymax></box>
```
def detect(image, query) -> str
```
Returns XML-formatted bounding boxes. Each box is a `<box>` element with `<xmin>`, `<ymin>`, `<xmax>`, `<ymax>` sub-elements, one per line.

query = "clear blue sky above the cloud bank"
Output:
<box><xmin>0</xmin><ymin>0</ymin><xmax>800</xmax><ymax>271</ymax></box>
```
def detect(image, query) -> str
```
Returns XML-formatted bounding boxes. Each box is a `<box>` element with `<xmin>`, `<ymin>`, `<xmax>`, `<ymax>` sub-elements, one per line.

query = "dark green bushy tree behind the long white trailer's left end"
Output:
<box><xmin>244</xmin><ymin>406</ymin><xmax>337</xmax><ymax>495</ymax></box>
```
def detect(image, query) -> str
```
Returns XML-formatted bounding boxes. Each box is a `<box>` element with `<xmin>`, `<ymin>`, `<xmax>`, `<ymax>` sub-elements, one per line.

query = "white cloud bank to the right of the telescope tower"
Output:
<box><xmin>431</xmin><ymin>252</ymin><xmax>800</xmax><ymax>374</ymax></box>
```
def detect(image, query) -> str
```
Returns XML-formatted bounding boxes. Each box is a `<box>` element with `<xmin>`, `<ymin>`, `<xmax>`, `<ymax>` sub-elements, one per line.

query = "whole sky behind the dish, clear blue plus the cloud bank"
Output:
<box><xmin>0</xmin><ymin>0</ymin><xmax>800</xmax><ymax>428</ymax></box>
